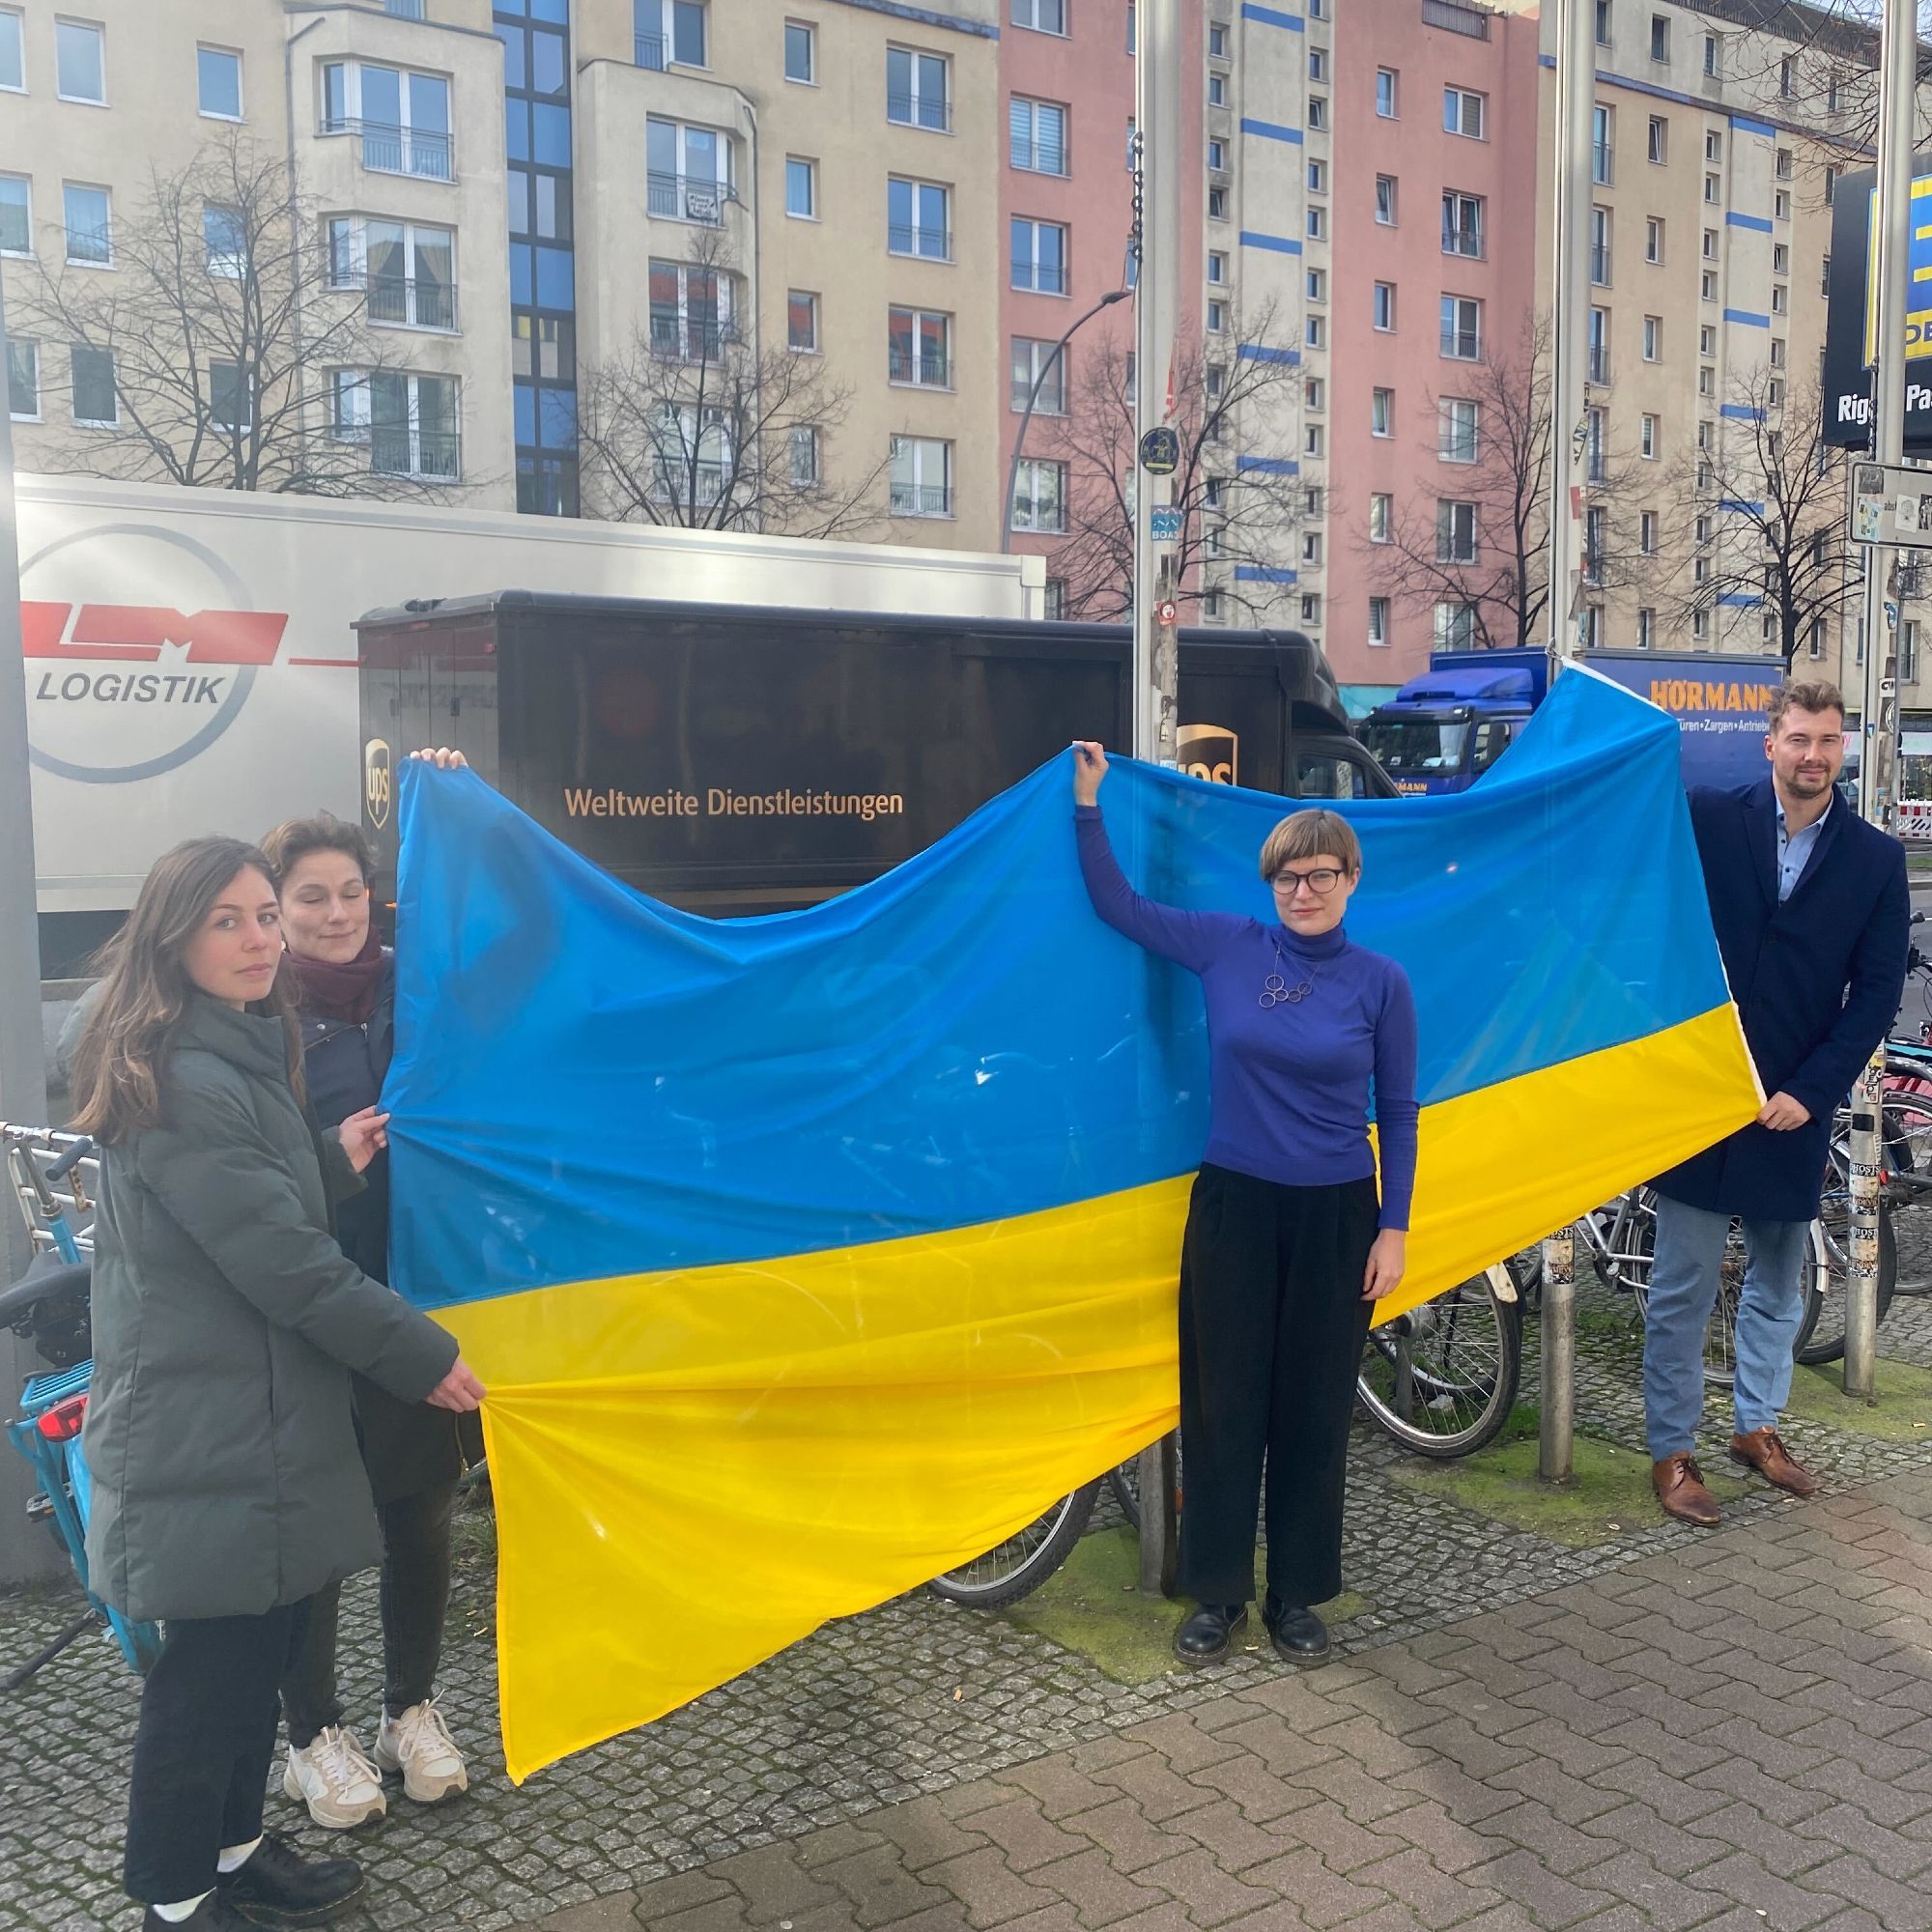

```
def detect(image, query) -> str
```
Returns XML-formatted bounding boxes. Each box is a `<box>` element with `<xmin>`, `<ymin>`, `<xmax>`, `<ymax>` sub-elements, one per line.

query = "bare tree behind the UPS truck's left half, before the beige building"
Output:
<box><xmin>578</xmin><ymin>232</ymin><xmax>885</xmax><ymax>537</ymax></box>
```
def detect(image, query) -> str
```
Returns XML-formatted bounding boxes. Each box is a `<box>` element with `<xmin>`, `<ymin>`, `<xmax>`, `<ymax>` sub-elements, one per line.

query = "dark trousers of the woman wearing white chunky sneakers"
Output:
<box><xmin>282</xmin><ymin>1482</ymin><xmax>456</xmax><ymax>1750</ymax></box>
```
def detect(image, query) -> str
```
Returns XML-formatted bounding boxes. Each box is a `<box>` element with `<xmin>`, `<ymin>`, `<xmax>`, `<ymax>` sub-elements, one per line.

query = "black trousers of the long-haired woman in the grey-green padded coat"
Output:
<box><xmin>124</xmin><ymin>1600</ymin><xmax>309</xmax><ymax>1905</ymax></box>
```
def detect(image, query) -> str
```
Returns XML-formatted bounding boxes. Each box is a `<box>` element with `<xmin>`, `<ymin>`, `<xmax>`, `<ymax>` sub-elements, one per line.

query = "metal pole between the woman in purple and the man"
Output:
<box><xmin>1536</xmin><ymin>0</ymin><xmax>1596</xmax><ymax>1482</ymax></box>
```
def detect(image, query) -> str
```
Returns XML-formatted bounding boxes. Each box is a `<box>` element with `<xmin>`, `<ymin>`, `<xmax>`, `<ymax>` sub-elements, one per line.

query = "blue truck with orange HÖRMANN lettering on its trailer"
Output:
<box><xmin>1360</xmin><ymin>649</ymin><xmax>1785</xmax><ymax>796</ymax></box>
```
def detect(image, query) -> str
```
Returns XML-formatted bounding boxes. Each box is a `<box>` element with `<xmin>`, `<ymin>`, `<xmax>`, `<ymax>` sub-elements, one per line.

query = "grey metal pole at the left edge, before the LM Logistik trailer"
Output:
<box><xmin>0</xmin><ymin>261</ymin><xmax>50</xmax><ymax>1582</ymax></box>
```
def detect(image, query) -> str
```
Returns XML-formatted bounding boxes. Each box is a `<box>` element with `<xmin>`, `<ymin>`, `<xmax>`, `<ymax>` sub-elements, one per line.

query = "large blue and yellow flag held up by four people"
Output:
<box><xmin>388</xmin><ymin>672</ymin><xmax>1758</xmax><ymax>1777</ymax></box>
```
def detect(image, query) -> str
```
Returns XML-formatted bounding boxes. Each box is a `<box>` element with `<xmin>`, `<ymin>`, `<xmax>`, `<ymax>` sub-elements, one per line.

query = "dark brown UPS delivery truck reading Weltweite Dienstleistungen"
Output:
<box><xmin>355</xmin><ymin>591</ymin><xmax>1395</xmax><ymax>916</ymax></box>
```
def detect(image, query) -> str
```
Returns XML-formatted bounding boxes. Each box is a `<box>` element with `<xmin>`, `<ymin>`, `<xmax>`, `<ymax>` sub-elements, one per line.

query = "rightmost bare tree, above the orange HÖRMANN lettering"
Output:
<box><xmin>1669</xmin><ymin>369</ymin><xmax>1859</xmax><ymax>670</ymax></box>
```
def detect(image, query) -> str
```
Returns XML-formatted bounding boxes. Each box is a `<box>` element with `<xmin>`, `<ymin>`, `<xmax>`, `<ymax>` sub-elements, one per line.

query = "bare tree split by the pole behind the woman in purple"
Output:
<box><xmin>1036</xmin><ymin>307</ymin><xmax>1308</xmax><ymax>620</ymax></box>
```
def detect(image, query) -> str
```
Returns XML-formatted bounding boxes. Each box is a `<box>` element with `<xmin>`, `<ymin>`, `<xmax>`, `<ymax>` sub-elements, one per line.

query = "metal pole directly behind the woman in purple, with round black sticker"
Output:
<box><xmin>1130</xmin><ymin>0</ymin><xmax>1180</xmax><ymax>1596</ymax></box>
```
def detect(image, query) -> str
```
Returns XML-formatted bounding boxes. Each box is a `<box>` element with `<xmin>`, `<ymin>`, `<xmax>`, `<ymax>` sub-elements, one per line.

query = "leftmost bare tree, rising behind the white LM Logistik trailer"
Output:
<box><xmin>8</xmin><ymin>135</ymin><xmax>460</xmax><ymax>497</ymax></box>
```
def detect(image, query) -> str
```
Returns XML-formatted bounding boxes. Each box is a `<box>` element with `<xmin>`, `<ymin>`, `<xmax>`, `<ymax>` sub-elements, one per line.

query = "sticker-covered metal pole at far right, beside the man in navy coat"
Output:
<box><xmin>1845</xmin><ymin>0</ymin><xmax>1918</xmax><ymax>1397</ymax></box>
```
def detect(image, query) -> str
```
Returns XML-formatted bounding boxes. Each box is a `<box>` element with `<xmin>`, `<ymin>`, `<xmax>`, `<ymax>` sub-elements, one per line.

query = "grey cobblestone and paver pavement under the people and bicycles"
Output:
<box><xmin>0</xmin><ymin>1298</ymin><xmax>1932</xmax><ymax>1932</ymax></box>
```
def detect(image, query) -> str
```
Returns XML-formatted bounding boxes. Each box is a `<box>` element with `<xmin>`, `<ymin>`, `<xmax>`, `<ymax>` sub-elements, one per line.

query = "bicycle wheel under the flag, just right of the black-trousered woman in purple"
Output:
<box><xmin>1356</xmin><ymin>1260</ymin><xmax>1528</xmax><ymax>1461</ymax></box>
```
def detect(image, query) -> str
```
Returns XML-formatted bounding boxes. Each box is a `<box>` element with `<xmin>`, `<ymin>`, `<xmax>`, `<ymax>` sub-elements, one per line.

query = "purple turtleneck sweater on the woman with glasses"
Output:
<box><xmin>1074</xmin><ymin>806</ymin><xmax>1416</xmax><ymax>1229</ymax></box>
